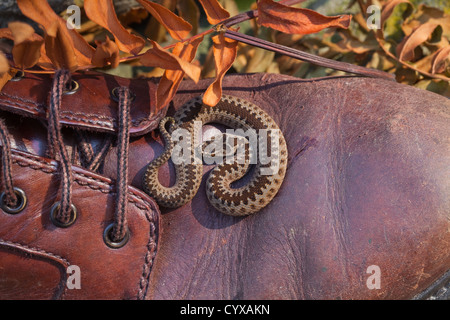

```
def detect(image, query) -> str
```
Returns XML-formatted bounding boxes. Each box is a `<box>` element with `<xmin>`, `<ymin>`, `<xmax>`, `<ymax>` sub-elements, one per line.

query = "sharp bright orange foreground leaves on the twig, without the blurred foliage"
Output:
<box><xmin>0</xmin><ymin>0</ymin><xmax>356</xmax><ymax>110</ymax></box>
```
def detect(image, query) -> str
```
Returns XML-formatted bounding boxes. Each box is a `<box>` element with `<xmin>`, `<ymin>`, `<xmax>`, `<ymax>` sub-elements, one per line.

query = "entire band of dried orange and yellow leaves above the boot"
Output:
<box><xmin>0</xmin><ymin>0</ymin><xmax>450</xmax><ymax>110</ymax></box>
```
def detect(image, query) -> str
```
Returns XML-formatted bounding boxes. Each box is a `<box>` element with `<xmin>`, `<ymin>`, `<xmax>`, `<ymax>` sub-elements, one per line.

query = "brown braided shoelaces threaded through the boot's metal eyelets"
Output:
<box><xmin>0</xmin><ymin>70</ymin><xmax>133</xmax><ymax>248</ymax></box>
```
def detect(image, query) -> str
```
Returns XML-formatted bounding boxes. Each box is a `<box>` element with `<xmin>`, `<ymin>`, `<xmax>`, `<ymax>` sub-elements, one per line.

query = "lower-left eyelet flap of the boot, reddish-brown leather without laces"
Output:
<box><xmin>0</xmin><ymin>151</ymin><xmax>160</xmax><ymax>299</ymax></box>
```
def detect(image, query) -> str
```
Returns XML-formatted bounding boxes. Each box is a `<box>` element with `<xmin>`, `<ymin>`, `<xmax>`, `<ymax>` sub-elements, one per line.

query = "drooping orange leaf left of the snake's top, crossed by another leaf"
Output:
<box><xmin>156</xmin><ymin>37</ymin><xmax>203</xmax><ymax>111</ymax></box>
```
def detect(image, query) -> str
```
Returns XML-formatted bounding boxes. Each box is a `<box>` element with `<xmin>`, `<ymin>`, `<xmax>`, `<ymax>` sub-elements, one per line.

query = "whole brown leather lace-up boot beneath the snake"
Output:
<box><xmin>0</xmin><ymin>72</ymin><xmax>450</xmax><ymax>299</ymax></box>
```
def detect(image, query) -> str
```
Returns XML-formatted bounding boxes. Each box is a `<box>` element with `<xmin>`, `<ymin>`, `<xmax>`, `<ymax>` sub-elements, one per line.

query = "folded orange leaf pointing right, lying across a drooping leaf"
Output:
<box><xmin>140</xmin><ymin>40</ymin><xmax>201</xmax><ymax>82</ymax></box>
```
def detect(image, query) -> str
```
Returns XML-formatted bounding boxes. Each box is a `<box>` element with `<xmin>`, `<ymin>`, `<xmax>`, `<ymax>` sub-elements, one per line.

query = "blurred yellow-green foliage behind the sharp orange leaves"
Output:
<box><xmin>0</xmin><ymin>0</ymin><xmax>450</xmax><ymax>97</ymax></box>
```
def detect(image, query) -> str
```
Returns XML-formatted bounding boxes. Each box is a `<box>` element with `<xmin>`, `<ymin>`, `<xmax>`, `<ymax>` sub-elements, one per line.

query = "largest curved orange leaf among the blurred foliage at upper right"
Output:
<box><xmin>396</xmin><ymin>22</ymin><xmax>438</xmax><ymax>61</ymax></box>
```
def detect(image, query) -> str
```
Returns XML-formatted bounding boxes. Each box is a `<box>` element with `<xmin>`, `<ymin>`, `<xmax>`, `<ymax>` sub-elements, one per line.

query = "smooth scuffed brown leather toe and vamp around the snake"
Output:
<box><xmin>0</xmin><ymin>74</ymin><xmax>450</xmax><ymax>299</ymax></box>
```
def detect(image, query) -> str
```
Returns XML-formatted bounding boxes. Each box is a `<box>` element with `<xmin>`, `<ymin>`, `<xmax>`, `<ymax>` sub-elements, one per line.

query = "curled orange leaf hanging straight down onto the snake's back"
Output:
<box><xmin>203</xmin><ymin>33</ymin><xmax>238</xmax><ymax>107</ymax></box>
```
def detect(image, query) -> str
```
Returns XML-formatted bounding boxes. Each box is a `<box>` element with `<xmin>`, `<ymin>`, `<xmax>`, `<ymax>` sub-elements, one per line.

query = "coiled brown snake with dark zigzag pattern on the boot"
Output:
<box><xmin>143</xmin><ymin>95</ymin><xmax>287</xmax><ymax>216</ymax></box>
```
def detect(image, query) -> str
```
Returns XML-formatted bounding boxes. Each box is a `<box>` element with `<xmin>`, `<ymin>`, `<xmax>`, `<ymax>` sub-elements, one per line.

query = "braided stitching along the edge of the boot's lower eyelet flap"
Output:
<box><xmin>8</xmin><ymin>151</ymin><xmax>158</xmax><ymax>300</ymax></box>
